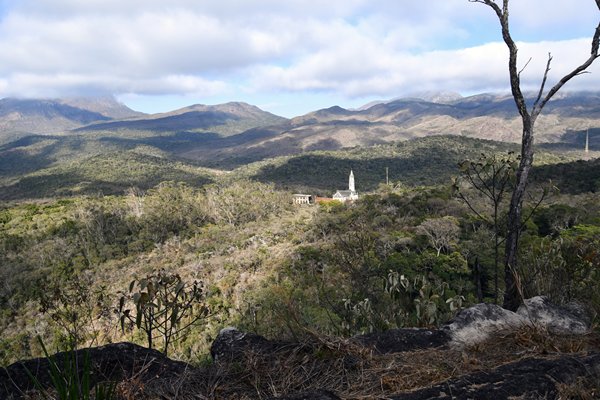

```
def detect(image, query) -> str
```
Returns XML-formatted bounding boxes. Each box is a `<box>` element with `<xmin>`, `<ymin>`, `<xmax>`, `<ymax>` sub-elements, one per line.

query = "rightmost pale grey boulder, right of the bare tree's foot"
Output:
<box><xmin>517</xmin><ymin>296</ymin><xmax>591</xmax><ymax>335</ymax></box>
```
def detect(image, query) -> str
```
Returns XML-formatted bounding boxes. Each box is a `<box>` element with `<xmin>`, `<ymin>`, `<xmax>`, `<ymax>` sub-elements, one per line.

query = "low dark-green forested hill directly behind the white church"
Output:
<box><xmin>240</xmin><ymin>136</ymin><xmax>600</xmax><ymax>196</ymax></box>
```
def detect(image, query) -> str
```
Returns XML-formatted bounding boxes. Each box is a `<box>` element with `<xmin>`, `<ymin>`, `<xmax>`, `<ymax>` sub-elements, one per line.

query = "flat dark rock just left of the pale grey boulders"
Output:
<box><xmin>353</xmin><ymin>328</ymin><xmax>450</xmax><ymax>354</ymax></box>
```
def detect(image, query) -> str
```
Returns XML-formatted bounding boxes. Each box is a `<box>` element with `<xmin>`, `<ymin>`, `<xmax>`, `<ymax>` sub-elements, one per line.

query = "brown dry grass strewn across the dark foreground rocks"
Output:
<box><xmin>109</xmin><ymin>327</ymin><xmax>600</xmax><ymax>400</ymax></box>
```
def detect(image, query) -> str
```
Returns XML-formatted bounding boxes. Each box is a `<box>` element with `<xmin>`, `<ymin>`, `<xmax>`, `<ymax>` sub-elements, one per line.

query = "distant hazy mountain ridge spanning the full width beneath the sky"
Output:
<box><xmin>0</xmin><ymin>92</ymin><xmax>600</xmax><ymax>169</ymax></box>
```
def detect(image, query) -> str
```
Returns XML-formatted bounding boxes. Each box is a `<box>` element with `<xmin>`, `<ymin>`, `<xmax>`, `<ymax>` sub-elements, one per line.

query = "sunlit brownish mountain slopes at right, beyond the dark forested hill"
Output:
<box><xmin>180</xmin><ymin>93</ymin><xmax>600</xmax><ymax>168</ymax></box>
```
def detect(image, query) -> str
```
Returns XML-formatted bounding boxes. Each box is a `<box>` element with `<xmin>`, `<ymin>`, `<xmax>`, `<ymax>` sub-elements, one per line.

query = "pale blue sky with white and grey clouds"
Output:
<box><xmin>0</xmin><ymin>0</ymin><xmax>600</xmax><ymax>117</ymax></box>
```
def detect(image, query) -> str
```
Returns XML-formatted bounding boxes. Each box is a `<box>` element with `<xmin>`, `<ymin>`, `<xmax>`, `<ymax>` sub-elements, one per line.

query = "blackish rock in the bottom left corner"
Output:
<box><xmin>0</xmin><ymin>343</ymin><xmax>189</xmax><ymax>399</ymax></box>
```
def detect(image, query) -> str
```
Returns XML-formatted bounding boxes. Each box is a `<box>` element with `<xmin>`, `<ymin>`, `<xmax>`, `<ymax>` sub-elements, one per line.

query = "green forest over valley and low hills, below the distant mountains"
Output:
<box><xmin>0</xmin><ymin>137</ymin><xmax>600</xmax><ymax>365</ymax></box>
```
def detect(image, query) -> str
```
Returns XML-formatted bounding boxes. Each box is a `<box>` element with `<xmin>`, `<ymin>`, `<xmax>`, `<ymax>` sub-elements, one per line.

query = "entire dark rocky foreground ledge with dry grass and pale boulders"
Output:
<box><xmin>0</xmin><ymin>298</ymin><xmax>600</xmax><ymax>400</ymax></box>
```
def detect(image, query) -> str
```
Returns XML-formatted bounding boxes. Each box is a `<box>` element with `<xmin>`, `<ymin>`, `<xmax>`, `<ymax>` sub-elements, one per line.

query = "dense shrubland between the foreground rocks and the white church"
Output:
<box><xmin>0</xmin><ymin>155</ymin><xmax>600</xmax><ymax>363</ymax></box>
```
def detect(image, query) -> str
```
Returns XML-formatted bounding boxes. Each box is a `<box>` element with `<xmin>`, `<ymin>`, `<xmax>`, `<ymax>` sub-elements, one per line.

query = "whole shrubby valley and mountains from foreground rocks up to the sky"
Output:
<box><xmin>0</xmin><ymin>93</ymin><xmax>600</xmax><ymax>398</ymax></box>
